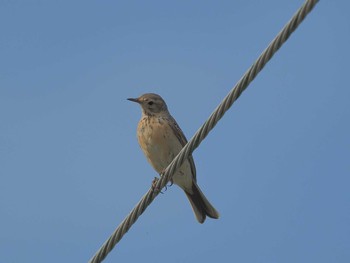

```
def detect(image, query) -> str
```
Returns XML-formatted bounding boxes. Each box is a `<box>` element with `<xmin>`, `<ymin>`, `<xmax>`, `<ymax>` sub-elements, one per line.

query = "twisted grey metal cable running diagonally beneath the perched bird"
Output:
<box><xmin>89</xmin><ymin>0</ymin><xmax>318</xmax><ymax>263</ymax></box>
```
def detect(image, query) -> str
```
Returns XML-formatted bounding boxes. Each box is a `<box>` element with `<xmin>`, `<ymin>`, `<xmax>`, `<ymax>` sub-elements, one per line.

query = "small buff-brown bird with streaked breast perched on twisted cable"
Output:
<box><xmin>128</xmin><ymin>93</ymin><xmax>219</xmax><ymax>224</ymax></box>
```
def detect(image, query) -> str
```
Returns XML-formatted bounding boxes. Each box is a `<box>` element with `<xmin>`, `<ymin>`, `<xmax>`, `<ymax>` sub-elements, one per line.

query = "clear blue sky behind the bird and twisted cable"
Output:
<box><xmin>0</xmin><ymin>0</ymin><xmax>350</xmax><ymax>263</ymax></box>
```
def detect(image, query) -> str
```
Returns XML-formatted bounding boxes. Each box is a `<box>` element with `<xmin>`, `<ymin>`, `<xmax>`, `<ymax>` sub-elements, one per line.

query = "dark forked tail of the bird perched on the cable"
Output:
<box><xmin>185</xmin><ymin>181</ymin><xmax>219</xmax><ymax>224</ymax></box>
